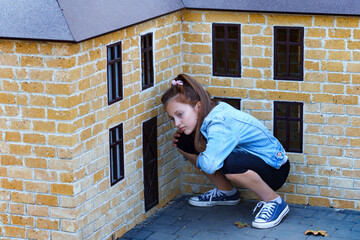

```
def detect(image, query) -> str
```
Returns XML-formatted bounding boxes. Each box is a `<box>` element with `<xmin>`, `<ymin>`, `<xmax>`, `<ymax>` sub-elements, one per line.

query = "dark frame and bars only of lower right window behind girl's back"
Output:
<box><xmin>274</xmin><ymin>101</ymin><xmax>304</xmax><ymax>153</ymax></box>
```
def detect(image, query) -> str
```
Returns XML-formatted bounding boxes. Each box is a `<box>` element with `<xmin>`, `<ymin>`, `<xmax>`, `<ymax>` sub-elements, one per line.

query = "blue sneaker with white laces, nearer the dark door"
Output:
<box><xmin>189</xmin><ymin>188</ymin><xmax>240</xmax><ymax>207</ymax></box>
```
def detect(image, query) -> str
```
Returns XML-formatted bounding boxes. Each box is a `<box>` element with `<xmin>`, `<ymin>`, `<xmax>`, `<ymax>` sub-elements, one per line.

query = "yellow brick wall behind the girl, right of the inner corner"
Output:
<box><xmin>183</xmin><ymin>10</ymin><xmax>360</xmax><ymax>209</ymax></box>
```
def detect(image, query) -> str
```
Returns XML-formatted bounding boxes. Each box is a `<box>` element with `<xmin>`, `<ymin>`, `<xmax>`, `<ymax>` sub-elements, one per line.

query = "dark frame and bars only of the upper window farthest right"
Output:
<box><xmin>274</xmin><ymin>26</ymin><xmax>304</xmax><ymax>81</ymax></box>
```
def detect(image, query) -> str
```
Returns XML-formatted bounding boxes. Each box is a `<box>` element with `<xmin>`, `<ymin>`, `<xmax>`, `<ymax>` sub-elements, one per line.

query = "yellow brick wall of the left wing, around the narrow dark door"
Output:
<box><xmin>0</xmin><ymin>13</ymin><xmax>183</xmax><ymax>239</ymax></box>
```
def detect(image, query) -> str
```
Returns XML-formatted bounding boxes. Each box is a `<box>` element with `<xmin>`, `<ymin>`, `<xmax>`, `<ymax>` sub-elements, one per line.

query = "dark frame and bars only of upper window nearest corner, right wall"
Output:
<box><xmin>212</xmin><ymin>23</ymin><xmax>241</xmax><ymax>77</ymax></box>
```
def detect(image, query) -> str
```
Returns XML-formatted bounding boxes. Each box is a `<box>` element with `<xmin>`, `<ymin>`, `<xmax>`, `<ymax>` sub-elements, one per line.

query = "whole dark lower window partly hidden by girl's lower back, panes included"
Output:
<box><xmin>274</xmin><ymin>102</ymin><xmax>303</xmax><ymax>152</ymax></box>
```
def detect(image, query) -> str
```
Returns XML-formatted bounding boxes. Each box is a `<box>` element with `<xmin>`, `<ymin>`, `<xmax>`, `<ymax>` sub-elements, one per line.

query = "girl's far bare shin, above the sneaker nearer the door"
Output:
<box><xmin>178</xmin><ymin>148</ymin><xmax>234</xmax><ymax>191</ymax></box>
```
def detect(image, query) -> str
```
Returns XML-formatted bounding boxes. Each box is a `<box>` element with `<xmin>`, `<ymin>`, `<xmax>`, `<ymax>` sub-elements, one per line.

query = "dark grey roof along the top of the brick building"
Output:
<box><xmin>0</xmin><ymin>0</ymin><xmax>360</xmax><ymax>42</ymax></box>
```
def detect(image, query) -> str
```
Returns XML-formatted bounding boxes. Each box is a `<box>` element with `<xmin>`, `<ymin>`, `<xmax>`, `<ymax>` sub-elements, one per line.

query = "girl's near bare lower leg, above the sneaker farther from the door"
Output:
<box><xmin>225</xmin><ymin>170</ymin><xmax>279</xmax><ymax>202</ymax></box>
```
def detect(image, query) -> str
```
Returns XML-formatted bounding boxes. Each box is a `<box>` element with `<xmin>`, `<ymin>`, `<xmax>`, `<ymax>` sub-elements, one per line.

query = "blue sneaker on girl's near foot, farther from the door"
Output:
<box><xmin>252</xmin><ymin>198</ymin><xmax>290</xmax><ymax>228</ymax></box>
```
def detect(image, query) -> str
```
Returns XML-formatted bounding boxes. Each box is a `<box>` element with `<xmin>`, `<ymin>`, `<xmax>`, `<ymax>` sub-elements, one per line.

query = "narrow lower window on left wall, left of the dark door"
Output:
<box><xmin>109</xmin><ymin>124</ymin><xmax>124</xmax><ymax>186</ymax></box>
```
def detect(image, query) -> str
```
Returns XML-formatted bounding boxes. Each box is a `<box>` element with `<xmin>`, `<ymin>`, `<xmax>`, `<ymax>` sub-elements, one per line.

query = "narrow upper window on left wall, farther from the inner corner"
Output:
<box><xmin>107</xmin><ymin>42</ymin><xmax>123</xmax><ymax>105</ymax></box>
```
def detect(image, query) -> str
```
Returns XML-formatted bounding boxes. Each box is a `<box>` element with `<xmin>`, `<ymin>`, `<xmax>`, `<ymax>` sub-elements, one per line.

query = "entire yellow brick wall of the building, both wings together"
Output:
<box><xmin>0</xmin><ymin>7</ymin><xmax>360</xmax><ymax>239</ymax></box>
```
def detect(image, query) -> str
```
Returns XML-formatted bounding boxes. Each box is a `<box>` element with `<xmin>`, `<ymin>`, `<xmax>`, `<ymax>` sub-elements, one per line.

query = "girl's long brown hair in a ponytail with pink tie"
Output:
<box><xmin>161</xmin><ymin>74</ymin><xmax>215</xmax><ymax>152</ymax></box>
